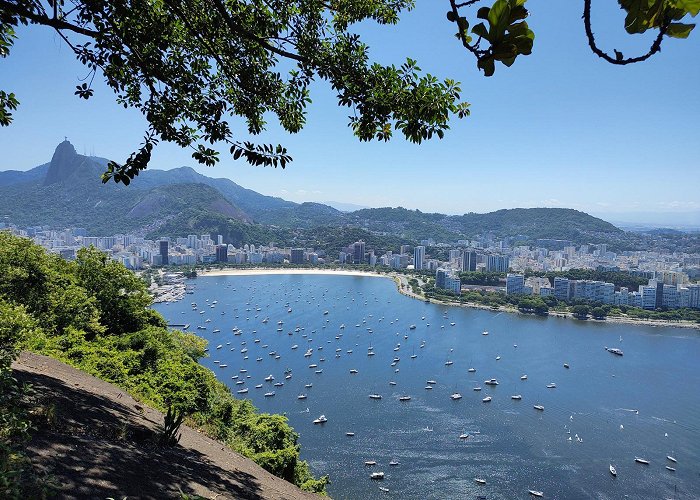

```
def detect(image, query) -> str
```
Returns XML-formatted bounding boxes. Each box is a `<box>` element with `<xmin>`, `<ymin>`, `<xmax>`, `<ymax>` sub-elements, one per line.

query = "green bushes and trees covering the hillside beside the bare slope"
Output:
<box><xmin>0</xmin><ymin>232</ymin><xmax>328</xmax><ymax>492</ymax></box>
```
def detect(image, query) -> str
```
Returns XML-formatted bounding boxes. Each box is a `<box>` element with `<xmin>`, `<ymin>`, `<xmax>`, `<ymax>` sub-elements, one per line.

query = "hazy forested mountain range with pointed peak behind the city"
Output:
<box><xmin>0</xmin><ymin>141</ymin><xmax>625</xmax><ymax>250</ymax></box>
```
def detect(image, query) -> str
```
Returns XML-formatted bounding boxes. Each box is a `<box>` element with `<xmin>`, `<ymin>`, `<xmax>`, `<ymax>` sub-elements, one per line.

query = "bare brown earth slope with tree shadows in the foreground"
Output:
<box><xmin>13</xmin><ymin>352</ymin><xmax>318</xmax><ymax>500</ymax></box>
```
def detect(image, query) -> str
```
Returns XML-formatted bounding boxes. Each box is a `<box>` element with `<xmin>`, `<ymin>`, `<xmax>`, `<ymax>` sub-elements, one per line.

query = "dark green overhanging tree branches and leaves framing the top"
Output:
<box><xmin>0</xmin><ymin>0</ymin><xmax>700</xmax><ymax>184</ymax></box>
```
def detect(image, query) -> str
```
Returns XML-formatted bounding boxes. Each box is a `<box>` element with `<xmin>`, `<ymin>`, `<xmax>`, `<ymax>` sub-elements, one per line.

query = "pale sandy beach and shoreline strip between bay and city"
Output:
<box><xmin>191</xmin><ymin>268</ymin><xmax>700</xmax><ymax>330</ymax></box>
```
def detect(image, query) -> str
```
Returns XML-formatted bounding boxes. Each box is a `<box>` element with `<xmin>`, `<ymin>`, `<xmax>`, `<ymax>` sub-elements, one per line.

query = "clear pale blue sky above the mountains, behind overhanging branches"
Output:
<box><xmin>0</xmin><ymin>0</ymin><xmax>700</xmax><ymax>218</ymax></box>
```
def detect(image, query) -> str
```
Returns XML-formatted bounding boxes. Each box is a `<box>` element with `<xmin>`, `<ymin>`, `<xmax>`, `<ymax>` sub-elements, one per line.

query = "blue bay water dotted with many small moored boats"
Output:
<box><xmin>156</xmin><ymin>275</ymin><xmax>700</xmax><ymax>499</ymax></box>
